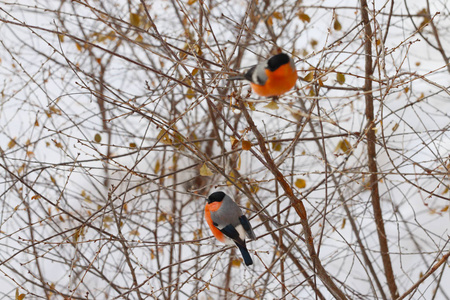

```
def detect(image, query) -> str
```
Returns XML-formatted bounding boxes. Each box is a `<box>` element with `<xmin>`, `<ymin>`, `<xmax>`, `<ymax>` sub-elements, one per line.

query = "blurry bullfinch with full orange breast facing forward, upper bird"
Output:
<box><xmin>228</xmin><ymin>53</ymin><xmax>297</xmax><ymax>97</ymax></box>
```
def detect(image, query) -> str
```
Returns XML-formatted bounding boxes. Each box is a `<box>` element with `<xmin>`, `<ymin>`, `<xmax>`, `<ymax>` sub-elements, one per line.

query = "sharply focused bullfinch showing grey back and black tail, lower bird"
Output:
<box><xmin>205</xmin><ymin>192</ymin><xmax>255</xmax><ymax>266</ymax></box>
